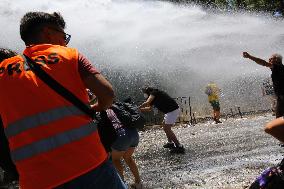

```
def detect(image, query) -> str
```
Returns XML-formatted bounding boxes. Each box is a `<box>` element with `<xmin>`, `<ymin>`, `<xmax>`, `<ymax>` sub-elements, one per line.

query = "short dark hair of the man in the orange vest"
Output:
<box><xmin>20</xmin><ymin>12</ymin><xmax>65</xmax><ymax>45</ymax></box>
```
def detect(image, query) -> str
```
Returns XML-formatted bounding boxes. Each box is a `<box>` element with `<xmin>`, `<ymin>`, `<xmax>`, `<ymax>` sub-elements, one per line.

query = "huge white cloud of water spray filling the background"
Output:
<box><xmin>0</xmin><ymin>0</ymin><xmax>284</xmax><ymax>114</ymax></box>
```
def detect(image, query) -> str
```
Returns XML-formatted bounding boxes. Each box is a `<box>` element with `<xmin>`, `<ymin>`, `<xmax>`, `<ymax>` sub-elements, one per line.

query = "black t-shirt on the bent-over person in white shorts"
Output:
<box><xmin>150</xmin><ymin>89</ymin><xmax>179</xmax><ymax>114</ymax></box>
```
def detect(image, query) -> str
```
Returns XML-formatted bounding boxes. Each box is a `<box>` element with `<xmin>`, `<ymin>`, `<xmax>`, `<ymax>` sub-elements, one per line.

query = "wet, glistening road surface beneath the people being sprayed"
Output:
<box><xmin>125</xmin><ymin>114</ymin><xmax>283</xmax><ymax>189</ymax></box>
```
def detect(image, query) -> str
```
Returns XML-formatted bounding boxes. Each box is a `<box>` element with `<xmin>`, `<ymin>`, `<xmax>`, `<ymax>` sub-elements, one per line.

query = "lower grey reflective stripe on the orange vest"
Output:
<box><xmin>11</xmin><ymin>121</ymin><xmax>97</xmax><ymax>161</ymax></box>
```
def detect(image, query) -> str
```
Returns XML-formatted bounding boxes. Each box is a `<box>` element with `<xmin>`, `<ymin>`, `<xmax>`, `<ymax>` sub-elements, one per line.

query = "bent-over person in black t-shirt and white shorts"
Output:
<box><xmin>140</xmin><ymin>87</ymin><xmax>185</xmax><ymax>153</ymax></box>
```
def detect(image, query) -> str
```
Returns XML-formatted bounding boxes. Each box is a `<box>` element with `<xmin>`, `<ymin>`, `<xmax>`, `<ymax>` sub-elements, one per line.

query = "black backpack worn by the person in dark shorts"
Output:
<box><xmin>111</xmin><ymin>102</ymin><xmax>146</xmax><ymax>130</ymax></box>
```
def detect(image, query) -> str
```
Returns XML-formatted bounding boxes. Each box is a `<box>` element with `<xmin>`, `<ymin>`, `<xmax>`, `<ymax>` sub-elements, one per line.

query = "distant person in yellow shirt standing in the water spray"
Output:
<box><xmin>205</xmin><ymin>82</ymin><xmax>222</xmax><ymax>124</ymax></box>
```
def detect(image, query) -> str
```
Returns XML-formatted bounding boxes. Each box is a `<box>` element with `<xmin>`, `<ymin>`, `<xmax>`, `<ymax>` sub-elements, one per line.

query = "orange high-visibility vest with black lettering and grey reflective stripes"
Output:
<box><xmin>0</xmin><ymin>44</ymin><xmax>107</xmax><ymax>189</ymax></box>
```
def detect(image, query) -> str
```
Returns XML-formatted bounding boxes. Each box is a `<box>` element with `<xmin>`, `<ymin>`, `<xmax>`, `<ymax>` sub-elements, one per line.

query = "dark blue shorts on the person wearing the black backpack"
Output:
<box><xmin>111</xmin><ymin>128</ymin><xmax>139</xmax><ymax>151</ymax></box>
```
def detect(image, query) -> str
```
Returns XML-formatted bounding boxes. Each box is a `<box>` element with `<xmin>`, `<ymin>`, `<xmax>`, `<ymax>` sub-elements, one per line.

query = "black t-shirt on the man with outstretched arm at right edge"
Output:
<box><xmin>271</xmin><ymin>64</ymin><xmax>284</xmax><ymax>95</ymax></box>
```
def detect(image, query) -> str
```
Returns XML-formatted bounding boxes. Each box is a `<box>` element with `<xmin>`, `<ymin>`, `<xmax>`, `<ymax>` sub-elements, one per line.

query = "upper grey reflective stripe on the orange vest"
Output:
<box><xmin>5</xmin><ymin>106</ymin><xmax>84</xmax><ymax>138</ymax></box>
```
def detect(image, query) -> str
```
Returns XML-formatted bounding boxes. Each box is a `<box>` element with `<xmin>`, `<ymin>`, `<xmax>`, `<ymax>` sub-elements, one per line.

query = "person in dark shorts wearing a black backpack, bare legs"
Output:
<box><xmin>101</xmin><ymin>99</ymin><xmax>143</xmax><ymax>189</ymax></box>
